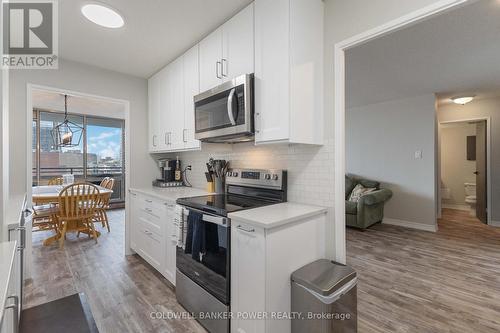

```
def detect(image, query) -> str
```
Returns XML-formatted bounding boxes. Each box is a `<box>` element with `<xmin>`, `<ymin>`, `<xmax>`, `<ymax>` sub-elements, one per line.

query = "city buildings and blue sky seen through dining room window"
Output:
<box><xmin>33</xmin><ymin>110</ymin><xmax>125</xmax><ymax>201</ymax></box>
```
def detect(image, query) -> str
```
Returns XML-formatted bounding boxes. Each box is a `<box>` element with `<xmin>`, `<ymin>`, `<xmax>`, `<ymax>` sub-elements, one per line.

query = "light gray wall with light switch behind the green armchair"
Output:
<box><xmin>346</xmin><ymin>95</ymin><xmax>436</xmax><ymax>225</ymax></box>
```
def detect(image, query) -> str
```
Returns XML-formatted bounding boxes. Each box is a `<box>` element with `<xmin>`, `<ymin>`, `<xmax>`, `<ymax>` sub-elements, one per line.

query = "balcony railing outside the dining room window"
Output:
<box><xmin>32</xmin><ymin>166</ymin><xmax>125</xmax><ymax>203</ymax></box>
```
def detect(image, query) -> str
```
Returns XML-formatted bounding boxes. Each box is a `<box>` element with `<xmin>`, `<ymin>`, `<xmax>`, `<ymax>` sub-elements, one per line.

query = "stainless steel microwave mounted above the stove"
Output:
<box><xmin>194</xmin><ymin>74</ymin><xmax>254</xmax><ymax>142</ymax></box>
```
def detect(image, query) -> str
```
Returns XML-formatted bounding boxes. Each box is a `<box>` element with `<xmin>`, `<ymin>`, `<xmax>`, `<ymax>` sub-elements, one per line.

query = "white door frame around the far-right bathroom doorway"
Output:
<box><xmin>436</xmin><ymin>117</ymin><xmax>492</xmax><ymax>225</ymax></box>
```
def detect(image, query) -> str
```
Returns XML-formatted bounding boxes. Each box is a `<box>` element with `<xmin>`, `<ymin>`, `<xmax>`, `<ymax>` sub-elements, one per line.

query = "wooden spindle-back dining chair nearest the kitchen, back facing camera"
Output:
<box><xmin>57</xmin><ymin>183</ymin><xmax>100</xmax><ymax>248</ymax></box>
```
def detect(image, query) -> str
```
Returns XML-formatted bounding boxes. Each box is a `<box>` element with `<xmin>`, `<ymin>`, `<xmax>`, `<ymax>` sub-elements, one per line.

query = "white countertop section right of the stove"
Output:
<box><xmin>228</xmin><ymin>202</ymin><xmax>327</xmax><ymax>229</ymax></box>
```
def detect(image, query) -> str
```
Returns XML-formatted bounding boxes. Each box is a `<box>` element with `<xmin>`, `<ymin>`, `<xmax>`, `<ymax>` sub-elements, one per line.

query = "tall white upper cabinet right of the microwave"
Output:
<box><xmin>254</xmin><ymin>0</ymin><xmax>324</xmax><ymax>144</ymax></box>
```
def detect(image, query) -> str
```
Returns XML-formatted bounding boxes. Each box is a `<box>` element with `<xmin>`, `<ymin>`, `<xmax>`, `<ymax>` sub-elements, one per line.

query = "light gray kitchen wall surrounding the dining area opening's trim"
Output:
<box><xmin>9</xmin><ymin>60</ymin><xmax>156</xmax><ymax>193</ymax></box>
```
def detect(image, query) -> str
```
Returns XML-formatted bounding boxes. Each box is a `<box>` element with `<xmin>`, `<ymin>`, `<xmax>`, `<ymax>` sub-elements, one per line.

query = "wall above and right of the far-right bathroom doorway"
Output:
<box><xmin>438</xmin><ymin>97</ymin><xmax>500</xmax><ymax>222</ymax></box>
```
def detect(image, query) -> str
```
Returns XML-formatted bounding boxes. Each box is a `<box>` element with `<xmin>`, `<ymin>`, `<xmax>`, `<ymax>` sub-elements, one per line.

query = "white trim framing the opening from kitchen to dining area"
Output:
<box><xmin>26</xmin><ymin>83</ymin><xmax>132</xmax><ymax>255</ymax></box>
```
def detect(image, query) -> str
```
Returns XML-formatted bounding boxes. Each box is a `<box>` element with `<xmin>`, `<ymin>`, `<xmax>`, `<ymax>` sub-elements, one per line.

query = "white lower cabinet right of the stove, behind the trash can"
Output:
<box><xmin>231</xmin><ymin>214</ymin><xmax>325</xmax><ymax>333</ymax></box>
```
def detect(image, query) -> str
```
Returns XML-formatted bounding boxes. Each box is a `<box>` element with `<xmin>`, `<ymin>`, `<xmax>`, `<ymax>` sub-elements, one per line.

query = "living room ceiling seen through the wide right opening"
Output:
<box><xmin>346</xmin><ymin>0</ymin><xmax>500</xmax><ymax>108</ymax></box>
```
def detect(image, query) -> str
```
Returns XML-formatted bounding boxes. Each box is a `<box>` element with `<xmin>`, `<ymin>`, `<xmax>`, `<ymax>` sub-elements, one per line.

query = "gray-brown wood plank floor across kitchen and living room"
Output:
<box><xmin>25</xmin><ymin>206</ymin><xmax>500</xmax><ymax>333</ymax></box>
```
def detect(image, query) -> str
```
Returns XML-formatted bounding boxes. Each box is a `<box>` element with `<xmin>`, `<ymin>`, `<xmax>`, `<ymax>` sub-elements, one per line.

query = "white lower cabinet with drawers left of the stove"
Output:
<box><xmin>129</xmin><ymin>192</ymin><xmax>176</xmax><ymax>285</ymax></box>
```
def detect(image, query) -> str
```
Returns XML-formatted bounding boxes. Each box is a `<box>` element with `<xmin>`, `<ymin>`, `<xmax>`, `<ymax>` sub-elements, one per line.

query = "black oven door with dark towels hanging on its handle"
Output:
<box><xmin>176</xmin><ymin>208</ymin><xmax>231</xmax><ymax>305</ymax></box>
